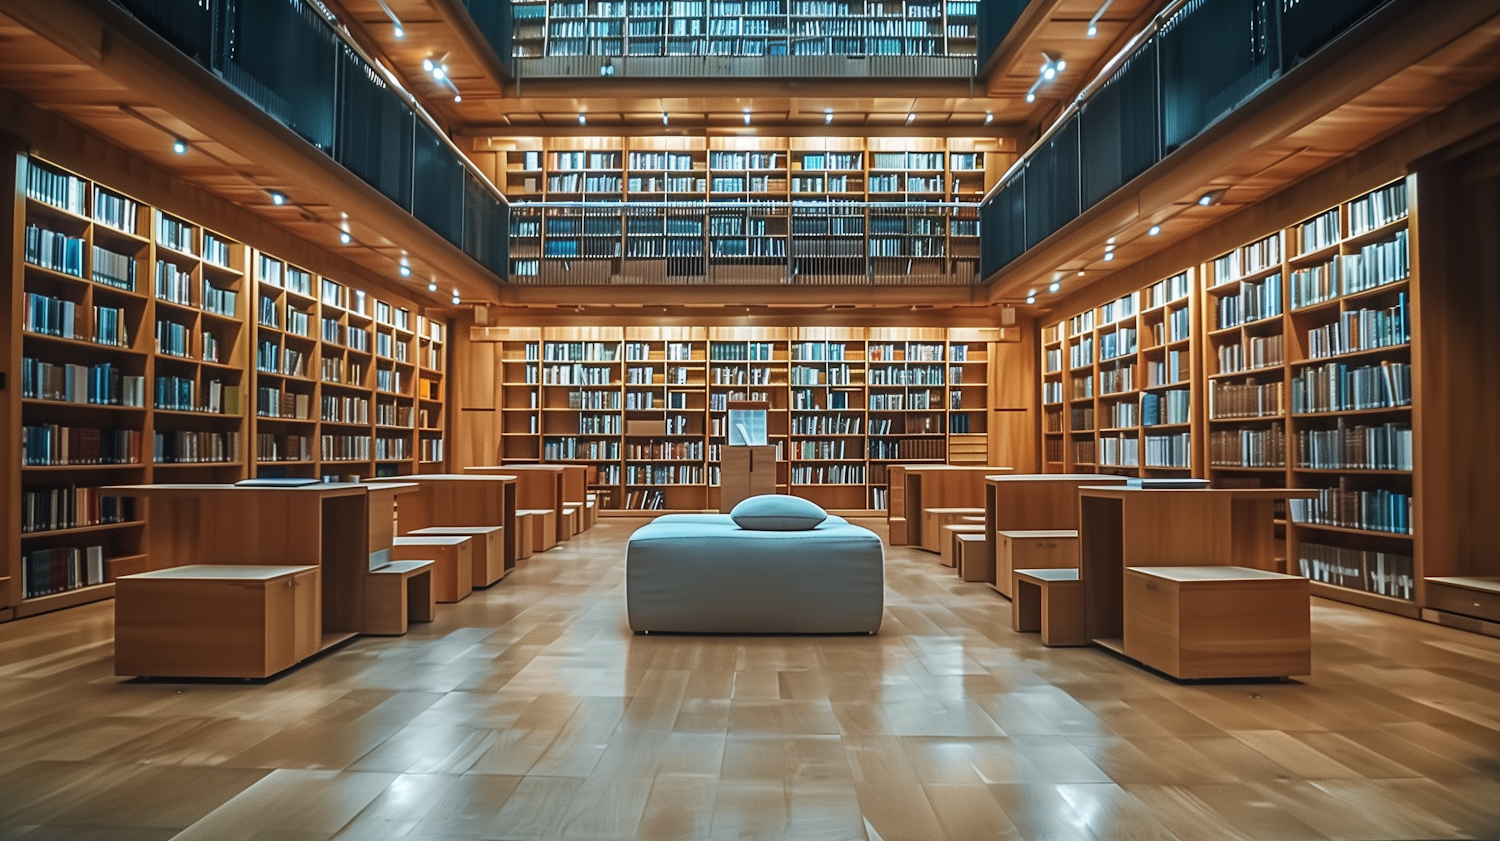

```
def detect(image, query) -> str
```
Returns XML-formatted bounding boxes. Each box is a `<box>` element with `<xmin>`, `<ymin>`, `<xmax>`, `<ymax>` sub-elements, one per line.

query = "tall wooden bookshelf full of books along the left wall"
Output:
<box><xmin>0</xmin><ymin>156</ymin><xmax>446</xmax><ymax>616</ymax></box>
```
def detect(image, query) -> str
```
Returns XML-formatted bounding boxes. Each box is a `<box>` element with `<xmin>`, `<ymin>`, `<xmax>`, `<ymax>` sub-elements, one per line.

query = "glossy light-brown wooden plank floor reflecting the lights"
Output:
<box><xmin>0</xmin><ymin>519</ymin><xmax>1500</xmax><ymax>841</ymax></box>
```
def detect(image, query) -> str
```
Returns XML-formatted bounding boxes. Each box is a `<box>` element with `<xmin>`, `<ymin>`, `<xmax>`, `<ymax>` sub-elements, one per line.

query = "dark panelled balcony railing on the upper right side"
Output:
<box><xmin>981</xmin><ymin>0</ymin><xmax>1388</xmax><ymax>277</ymax></box>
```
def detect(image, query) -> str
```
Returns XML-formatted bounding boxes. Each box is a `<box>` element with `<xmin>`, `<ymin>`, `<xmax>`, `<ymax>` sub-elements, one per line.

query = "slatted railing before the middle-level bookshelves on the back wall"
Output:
<box><xmin>510</xmin><ymin>201</ymin><xmax>980</xmax><ymax>286</ymax></box>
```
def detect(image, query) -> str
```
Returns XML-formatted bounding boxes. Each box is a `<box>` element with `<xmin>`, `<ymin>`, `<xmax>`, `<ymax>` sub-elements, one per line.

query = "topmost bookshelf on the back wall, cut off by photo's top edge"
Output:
<box><xmin>512</xmin><ymin>0</ymin><xmax>978</xmax><ymax>76</ymax></box>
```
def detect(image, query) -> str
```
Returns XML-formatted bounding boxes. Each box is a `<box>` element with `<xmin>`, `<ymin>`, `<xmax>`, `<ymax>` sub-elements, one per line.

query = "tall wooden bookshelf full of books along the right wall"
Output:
<box><xmin>1041</xmin><ymin>180</ymin><xmax>1421</xmax><ymax>616</ymax></box>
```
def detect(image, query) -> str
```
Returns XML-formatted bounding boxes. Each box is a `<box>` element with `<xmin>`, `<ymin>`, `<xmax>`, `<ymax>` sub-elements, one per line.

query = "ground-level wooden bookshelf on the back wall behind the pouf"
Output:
<box><xmin>497</xmin><ymin>327</ymin><xmax>999</xmax><ymax>510</ymax></box>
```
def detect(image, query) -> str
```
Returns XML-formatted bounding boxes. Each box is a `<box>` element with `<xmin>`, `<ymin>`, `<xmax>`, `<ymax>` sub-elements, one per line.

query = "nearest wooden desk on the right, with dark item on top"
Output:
<box><xmin>1079</xmin><ymin>486</ymin><xmax>1317</xmax><ymax>649</ymax></box>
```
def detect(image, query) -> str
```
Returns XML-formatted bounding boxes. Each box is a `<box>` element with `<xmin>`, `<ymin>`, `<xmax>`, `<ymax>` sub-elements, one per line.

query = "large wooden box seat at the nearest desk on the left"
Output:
<box><xmin>114</xmin><ymin>564</ymin><xmax>323</xmax><ymax>678</ymax></box>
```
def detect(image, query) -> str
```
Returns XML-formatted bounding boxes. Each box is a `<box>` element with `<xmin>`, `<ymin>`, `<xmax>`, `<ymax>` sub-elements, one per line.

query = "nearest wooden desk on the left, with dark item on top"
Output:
<box><xmin>101</xmin><ymin>483</ymin><xmax>416</xmax><ymax>651</ymax></box>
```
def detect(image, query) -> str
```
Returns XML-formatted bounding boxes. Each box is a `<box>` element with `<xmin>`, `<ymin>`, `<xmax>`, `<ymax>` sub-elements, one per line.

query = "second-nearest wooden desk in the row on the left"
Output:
<box><xmin>371</xmin><ymin>474</ymin><xmax>524</xmax><ymax>569</ymax></box>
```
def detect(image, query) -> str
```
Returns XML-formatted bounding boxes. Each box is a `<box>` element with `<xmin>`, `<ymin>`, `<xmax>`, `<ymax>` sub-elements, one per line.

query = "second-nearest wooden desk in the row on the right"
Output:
<box><xmin>984</xmin><ymin>474</ymin><xmax>1125</xmax><ymax>597</ymax></box>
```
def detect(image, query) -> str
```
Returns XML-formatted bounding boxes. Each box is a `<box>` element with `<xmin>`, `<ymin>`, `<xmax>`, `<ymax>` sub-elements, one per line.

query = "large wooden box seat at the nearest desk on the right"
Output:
<box><xmin>1124</xmin><ymin>567</ymin><xmax>1313</xmax><ymax>679</ymax></box>
